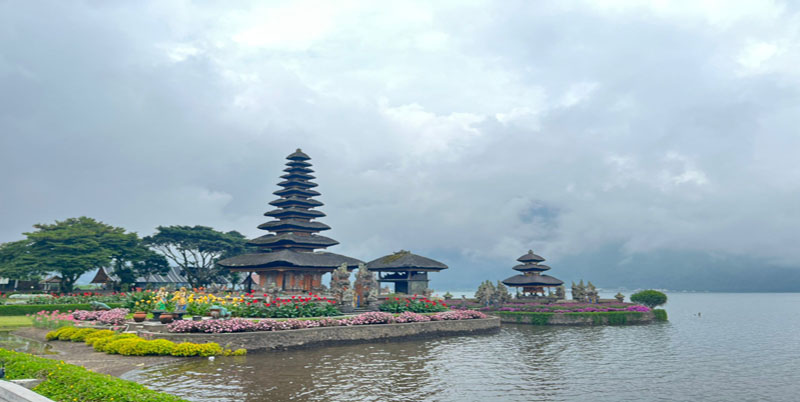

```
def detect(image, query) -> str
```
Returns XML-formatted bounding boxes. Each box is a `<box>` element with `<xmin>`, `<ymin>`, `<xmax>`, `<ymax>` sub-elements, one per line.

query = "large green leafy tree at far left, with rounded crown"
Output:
<box><xmin>23</xmin><ymin>216</ymin><xmax>126</xmax><ymax>292</ymax></box>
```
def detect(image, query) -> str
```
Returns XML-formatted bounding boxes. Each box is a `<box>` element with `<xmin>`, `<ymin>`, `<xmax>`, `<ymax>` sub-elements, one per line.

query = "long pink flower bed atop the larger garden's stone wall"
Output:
<box><xmin>167</xmin><ymin>310</ymin><xmax>486</xmax><ymax>334</ymax></box>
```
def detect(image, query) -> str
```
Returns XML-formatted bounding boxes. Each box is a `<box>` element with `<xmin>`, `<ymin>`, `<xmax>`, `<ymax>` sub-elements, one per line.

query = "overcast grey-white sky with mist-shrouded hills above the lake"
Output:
<box><xmin>0</xmin><ymin>0</ymin><xmax>800</xmax><ymax>290</ymax></box>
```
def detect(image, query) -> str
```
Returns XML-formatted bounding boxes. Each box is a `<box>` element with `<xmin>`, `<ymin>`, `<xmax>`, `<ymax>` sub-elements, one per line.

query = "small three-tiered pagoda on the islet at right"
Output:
<box><xmin>503</xmin><ymin>250</ymin><xmax>564</xmax><ymax>299</ymax></box>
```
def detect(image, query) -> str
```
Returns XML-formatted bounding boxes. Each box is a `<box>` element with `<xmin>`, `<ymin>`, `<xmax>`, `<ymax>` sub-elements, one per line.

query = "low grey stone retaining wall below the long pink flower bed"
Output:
<box><xmin>137</xmin><ymin>317</ymin><xmax>500</xmax><ymax>351</ymax></box>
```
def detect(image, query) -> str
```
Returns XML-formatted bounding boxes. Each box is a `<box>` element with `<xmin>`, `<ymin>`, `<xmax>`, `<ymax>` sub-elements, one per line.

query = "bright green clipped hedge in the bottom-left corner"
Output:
<box><xmin>0</xmin><ymin>349</ymin><xmax>184</xmax><ymax>402</ymax></box>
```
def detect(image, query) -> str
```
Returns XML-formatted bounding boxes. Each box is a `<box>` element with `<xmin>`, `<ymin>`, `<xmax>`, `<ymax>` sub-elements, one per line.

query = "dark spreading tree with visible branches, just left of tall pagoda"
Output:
<box><xmin>144</xmin><ymin>226</ymin><xmax>246</xmax><ymax>287</ymax></box>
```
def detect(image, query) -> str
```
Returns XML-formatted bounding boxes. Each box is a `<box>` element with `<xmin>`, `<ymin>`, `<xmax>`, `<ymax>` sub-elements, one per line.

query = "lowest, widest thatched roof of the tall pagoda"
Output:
<box><xmin>219</xmin><ymin>249</ymin><xmax>362</xmax><ymax>271</ymax></box>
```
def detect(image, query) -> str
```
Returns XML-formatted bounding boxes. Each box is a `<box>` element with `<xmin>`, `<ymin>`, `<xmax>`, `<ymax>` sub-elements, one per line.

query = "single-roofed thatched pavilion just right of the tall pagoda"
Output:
<box><xmin>367</xmin><ymin>250</ymin><xmax>447</xmax><ymax>294</ymax></box>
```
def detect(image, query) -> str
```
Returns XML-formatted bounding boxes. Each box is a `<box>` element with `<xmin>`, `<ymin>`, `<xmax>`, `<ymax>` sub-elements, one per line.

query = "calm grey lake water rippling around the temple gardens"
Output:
<box><xmin>124</xmin><ymin>293</ymin><xmax>800</xmax><ymax>401</ymax></box>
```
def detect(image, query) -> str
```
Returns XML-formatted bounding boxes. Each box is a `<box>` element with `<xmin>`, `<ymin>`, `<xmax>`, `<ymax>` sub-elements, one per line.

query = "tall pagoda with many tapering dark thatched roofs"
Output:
<box><xmin>219</xmin><ymin>149</ymin><xmax>361</xmax><ymax>292</ymax></box>
